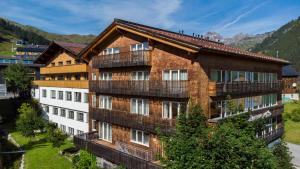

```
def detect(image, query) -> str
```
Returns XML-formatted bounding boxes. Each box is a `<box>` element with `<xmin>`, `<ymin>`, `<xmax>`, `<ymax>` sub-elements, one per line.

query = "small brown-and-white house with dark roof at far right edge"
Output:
<box><xmin>282</xmin><ymin>65</ymin><xmax>299</xmax><ymax>102</ymax></box>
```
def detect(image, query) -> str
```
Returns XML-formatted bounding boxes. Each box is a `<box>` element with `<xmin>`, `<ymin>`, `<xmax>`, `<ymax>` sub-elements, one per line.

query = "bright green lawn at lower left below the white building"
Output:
<box><xmin>11</xmin><ymin>132</ymin><xmax>73</xmax><ymax>169</ymax></box>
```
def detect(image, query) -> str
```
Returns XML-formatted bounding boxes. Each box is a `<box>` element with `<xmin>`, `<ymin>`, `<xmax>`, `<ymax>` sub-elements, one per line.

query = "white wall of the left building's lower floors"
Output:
<box><xmin>32</xmin><ymin>87</ymin><xmax>89</xmax><ymax>134</ymax></box>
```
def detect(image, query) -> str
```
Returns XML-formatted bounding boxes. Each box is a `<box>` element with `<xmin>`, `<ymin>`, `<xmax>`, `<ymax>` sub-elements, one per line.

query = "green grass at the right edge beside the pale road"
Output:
<box><xmin>284</xmin><ymin>103</ymin><xmax>300</xmax><ymax>144</ymax></box>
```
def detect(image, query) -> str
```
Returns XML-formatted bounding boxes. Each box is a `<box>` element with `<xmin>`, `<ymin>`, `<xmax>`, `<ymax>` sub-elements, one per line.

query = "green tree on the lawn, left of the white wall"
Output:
<box><xmin>16</xmin><ymin>103</ymin><xmax>44</xmax><ymax>140</ymax></box>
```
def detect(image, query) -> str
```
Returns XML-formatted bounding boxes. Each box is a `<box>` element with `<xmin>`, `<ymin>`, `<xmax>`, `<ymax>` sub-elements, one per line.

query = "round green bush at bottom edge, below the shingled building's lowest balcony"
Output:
<box><xmin>72</xmin><ymin>150</ymin><xmax>98</xmax><ymax>169</ymax></box>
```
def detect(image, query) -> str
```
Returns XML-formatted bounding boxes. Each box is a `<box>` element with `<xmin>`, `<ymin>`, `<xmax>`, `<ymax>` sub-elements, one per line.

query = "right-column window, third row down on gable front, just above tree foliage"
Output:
<box><xmin>162</xmin><ymin>101</ymin><xmax>186</xmax><ymax>119</ymax></box>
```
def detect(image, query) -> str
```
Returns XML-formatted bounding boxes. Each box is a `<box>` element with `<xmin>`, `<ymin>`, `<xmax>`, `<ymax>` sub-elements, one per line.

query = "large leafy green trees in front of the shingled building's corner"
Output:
<box><xmin>160</xmin><ymin>105</ymin><xmax>290</xmax><ymax>169</ymax></box>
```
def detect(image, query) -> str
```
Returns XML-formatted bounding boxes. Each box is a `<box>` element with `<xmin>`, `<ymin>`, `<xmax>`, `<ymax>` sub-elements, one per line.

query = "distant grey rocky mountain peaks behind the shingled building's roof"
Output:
<box><xmin>204</xmin><ymin>32</ymin><xmax>273</xmax><ymax>50</ymax></box>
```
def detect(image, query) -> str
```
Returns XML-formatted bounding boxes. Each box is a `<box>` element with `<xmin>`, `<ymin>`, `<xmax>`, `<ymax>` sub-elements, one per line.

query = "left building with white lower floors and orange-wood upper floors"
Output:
<box><xmin>32</xmin><ymin>42</ymin><xmax>89</xmax><ymax>136</ymax></box>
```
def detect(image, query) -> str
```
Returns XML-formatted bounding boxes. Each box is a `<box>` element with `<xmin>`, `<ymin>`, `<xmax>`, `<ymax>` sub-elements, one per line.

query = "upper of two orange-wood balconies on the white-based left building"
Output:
<box><xmin>40</xmin><ymin>64</ymin><xmax>89</xmax><ymax>75</ymax></box>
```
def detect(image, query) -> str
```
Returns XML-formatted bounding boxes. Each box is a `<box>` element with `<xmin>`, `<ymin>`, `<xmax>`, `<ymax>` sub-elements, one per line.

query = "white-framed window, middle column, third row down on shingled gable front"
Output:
<box><xmin>130</xmin><ymin>98</ymin><xmax>150</xmax><ymax>116</ymax></box>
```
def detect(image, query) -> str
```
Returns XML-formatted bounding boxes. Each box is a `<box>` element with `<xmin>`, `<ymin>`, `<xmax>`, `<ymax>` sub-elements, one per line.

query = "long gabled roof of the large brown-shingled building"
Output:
<box><xmin>79</xmin><ymin>19</ymin><xmax>289</xmax><ymax>64</ymax></box>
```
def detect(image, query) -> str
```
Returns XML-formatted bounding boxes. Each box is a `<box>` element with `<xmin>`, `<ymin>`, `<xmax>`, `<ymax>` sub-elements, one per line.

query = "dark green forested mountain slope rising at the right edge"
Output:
<box><xmin>252</xmin><ymin>17</ymin><xmax>300</xmax><ymax>71</ymax></box>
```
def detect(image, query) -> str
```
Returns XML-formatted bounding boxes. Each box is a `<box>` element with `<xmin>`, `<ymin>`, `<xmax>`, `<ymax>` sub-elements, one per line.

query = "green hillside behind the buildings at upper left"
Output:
<box><xmin>0</xmin><ymin>18</ymin><xmax>95</xmax><ymax>56</ymax></box>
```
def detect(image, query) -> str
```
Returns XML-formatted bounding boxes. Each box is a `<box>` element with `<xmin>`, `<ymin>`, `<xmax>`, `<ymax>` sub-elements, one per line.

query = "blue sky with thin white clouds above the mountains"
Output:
<box><xmin>0</xmin><ymin>0</ymin><xmax>300</xmax><ymax>37</ymax></box>
